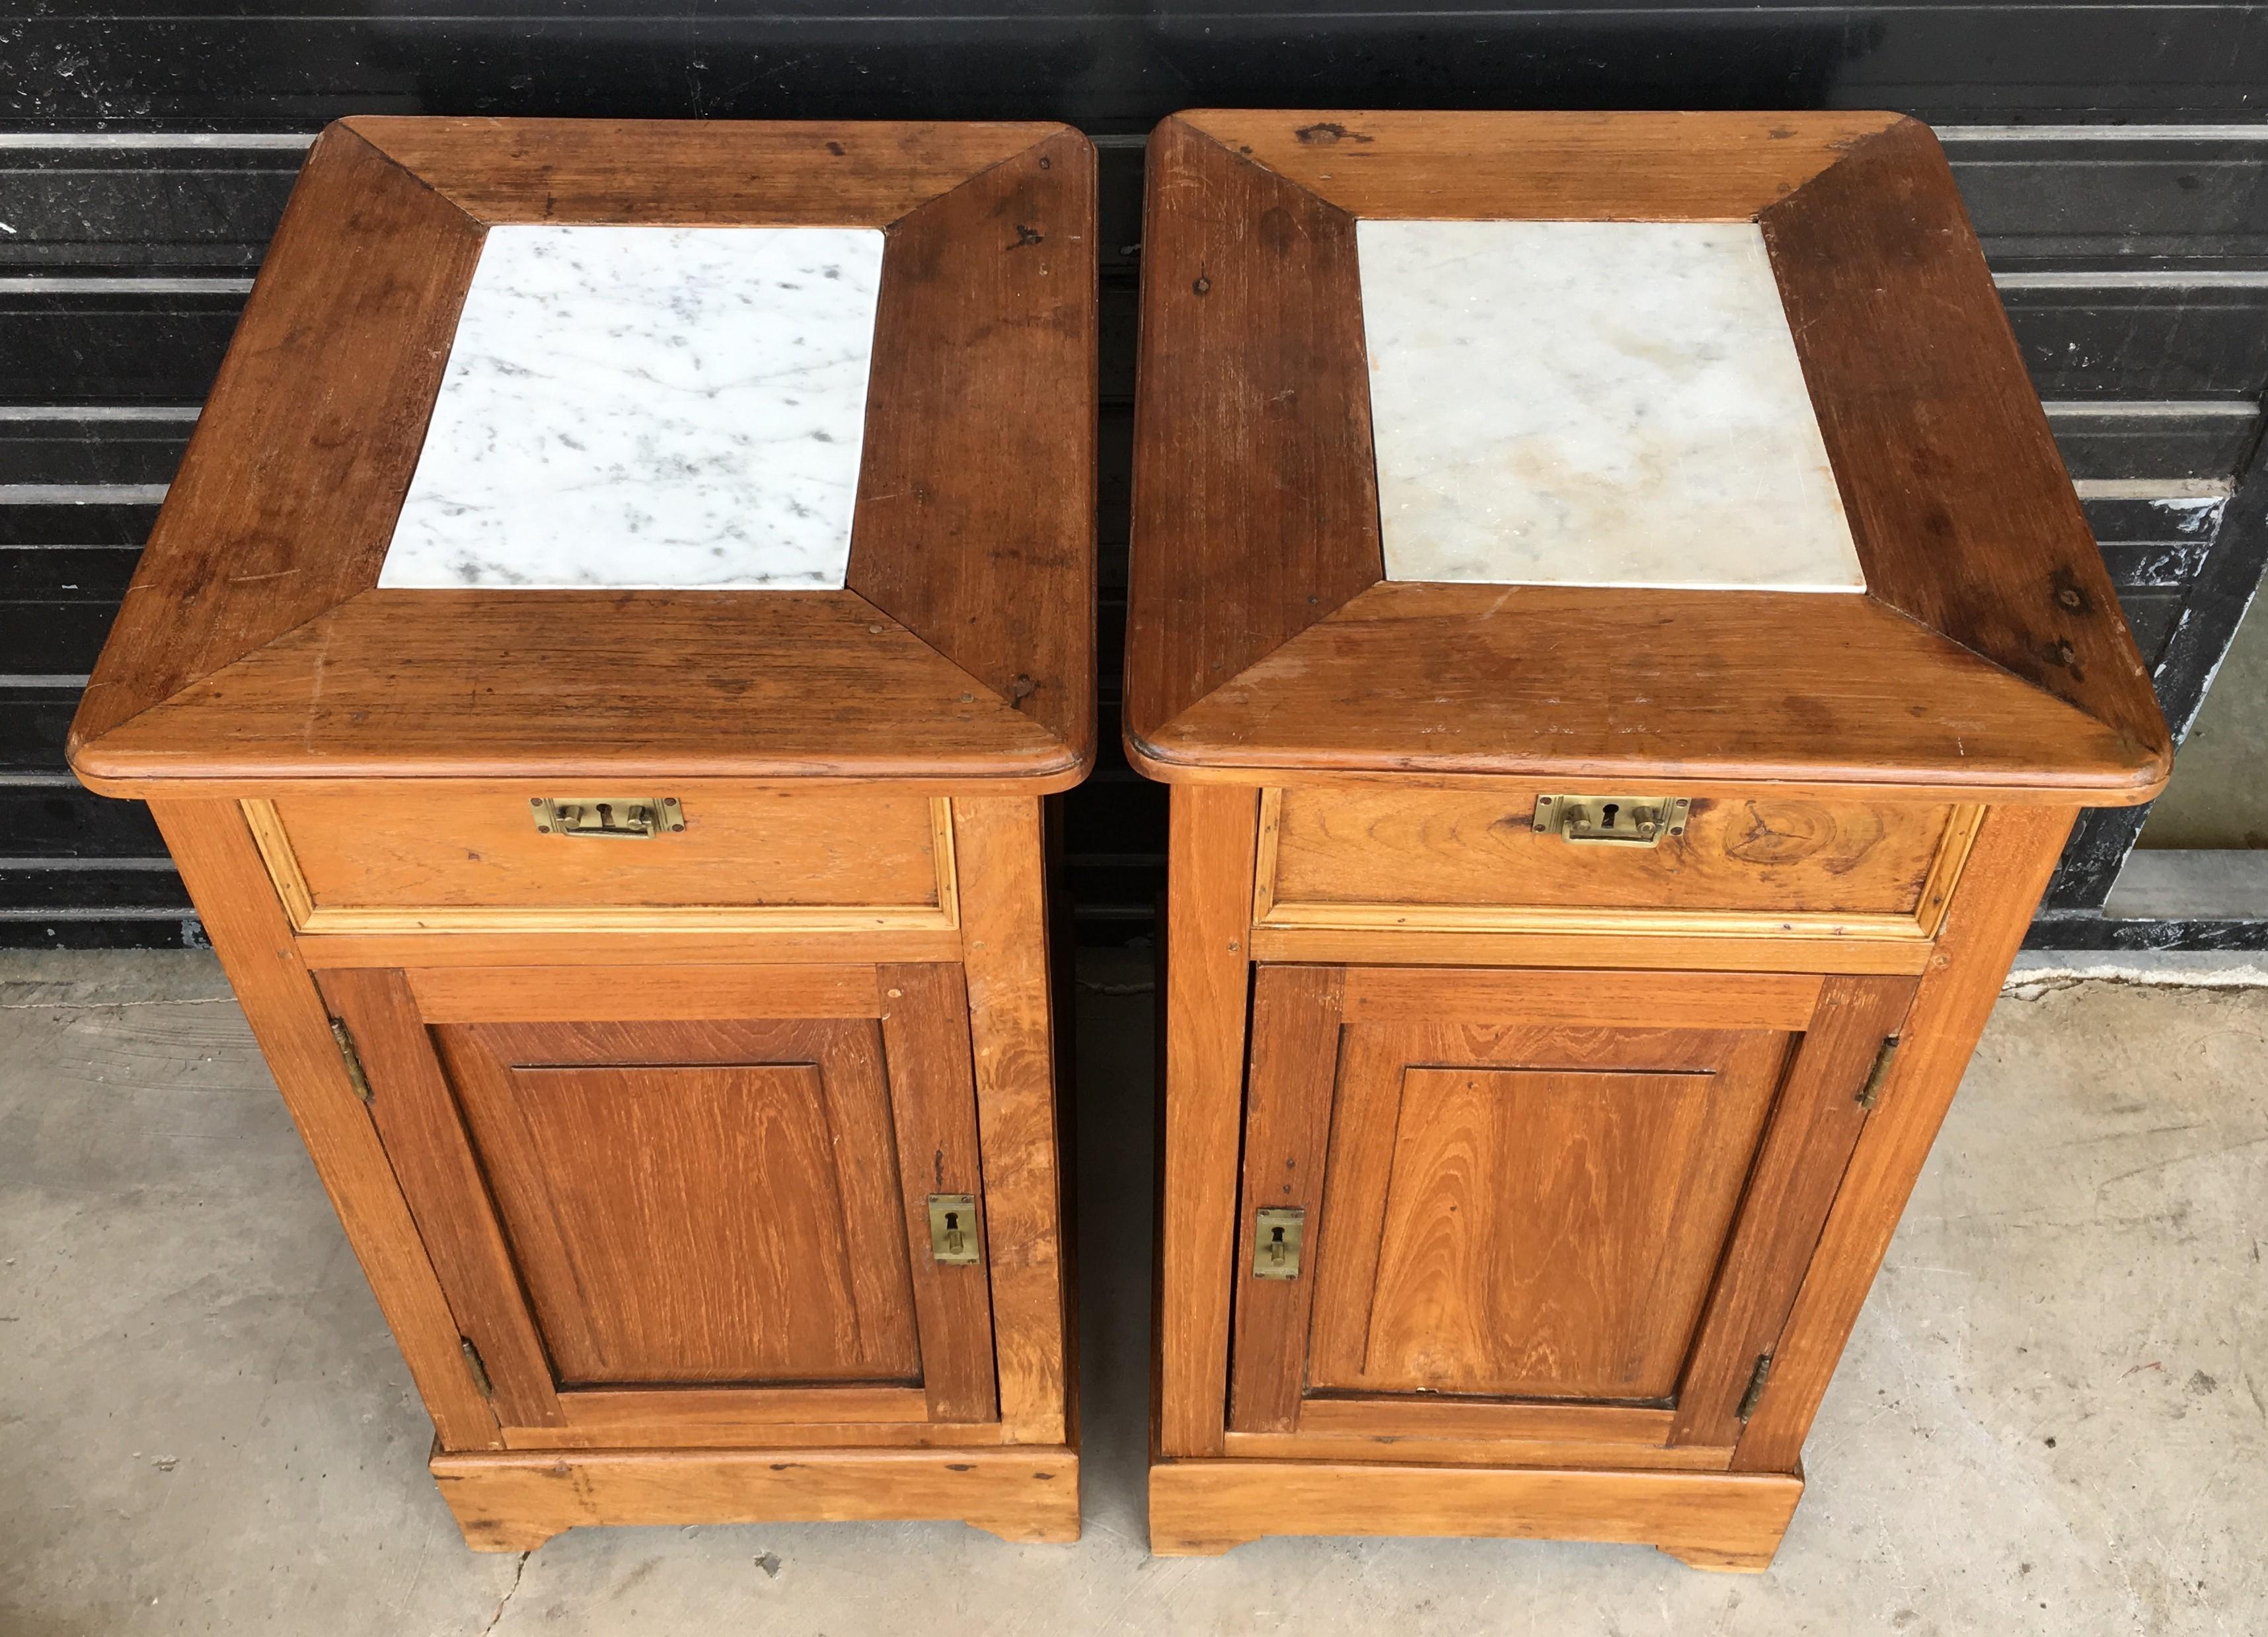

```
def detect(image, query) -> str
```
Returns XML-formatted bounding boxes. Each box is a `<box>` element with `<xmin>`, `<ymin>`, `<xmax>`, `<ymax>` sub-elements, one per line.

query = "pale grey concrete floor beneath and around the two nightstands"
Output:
<box><xmin>0</xmin><ymin>954</ymin><xmax>2268</xmax><ymax>1637</ymax></box>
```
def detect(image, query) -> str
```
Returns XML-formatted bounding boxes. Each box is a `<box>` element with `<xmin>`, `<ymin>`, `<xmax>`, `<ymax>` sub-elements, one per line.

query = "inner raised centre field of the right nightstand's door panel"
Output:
<box><xmin>1342</xmin><ymin>1065</ymin><xmax>1767</xmax><ymax>1399</ymax></box>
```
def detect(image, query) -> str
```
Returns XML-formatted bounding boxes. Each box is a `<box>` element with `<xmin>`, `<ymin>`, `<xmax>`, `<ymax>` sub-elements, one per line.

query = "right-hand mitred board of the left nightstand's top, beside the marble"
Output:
<box><xmin>846</xmin><ymin>130</ymin><xmax>1096</xmax><ymax>767</ymax></box>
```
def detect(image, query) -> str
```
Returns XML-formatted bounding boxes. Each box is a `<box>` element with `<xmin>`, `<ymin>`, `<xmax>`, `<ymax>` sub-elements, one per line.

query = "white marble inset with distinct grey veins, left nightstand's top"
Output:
<box><xmin>379</xmin><ymin>227</ymin><xmax>882</xmax><ymax>590</ymax></box>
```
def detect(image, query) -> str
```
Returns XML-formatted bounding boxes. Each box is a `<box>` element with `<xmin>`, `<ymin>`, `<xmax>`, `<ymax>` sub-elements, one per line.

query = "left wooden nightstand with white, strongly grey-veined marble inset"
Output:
<box><xmin>73</xmin><ymin>118</ymin><xmax>1096</xmax><ymax>1548</ymax></box>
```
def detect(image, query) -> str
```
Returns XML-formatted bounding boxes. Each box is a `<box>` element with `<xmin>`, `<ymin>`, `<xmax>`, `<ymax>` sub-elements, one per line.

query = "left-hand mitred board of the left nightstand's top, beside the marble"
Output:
<box><xmin>70</xmin><ymin>127</ymin><xmax>481</xmax><ymax>757</ymax></box>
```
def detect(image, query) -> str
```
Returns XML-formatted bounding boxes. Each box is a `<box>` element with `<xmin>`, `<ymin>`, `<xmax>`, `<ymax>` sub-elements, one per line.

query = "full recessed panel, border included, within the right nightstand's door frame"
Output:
<box><xmin>1306</xmin><ymin>1014</ymin><xmax>1783</xmax><ymax>1399</ymax></box>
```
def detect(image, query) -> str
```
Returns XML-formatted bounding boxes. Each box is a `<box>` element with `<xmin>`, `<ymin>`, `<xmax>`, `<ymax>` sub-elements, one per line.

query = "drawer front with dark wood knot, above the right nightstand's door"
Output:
<box><xmin>1254</xmin><ymin>789</ymin><xmax>1983</xmax><ymax>938</ymax></box>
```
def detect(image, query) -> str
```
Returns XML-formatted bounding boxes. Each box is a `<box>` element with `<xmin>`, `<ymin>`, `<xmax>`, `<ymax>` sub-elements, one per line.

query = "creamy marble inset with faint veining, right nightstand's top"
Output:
<box><xmin>1356</xmin><ymin>222</ymin><xmax>1867</xmax><ymax>591</ymax></box>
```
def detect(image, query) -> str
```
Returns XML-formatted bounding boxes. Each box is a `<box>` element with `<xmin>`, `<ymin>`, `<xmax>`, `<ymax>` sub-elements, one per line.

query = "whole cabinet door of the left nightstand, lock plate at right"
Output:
<box><xmin>322</xmin><ymin>966</ymin><xmax>996</xmax><ymax>1444</ymax></box>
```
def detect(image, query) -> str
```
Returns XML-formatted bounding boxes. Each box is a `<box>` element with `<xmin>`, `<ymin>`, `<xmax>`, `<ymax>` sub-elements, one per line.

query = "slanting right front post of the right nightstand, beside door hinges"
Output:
<box><xmin>1733</xmin><ymin>807</ymin><xmax>2078</xmax><ymax>1472</ymax></box>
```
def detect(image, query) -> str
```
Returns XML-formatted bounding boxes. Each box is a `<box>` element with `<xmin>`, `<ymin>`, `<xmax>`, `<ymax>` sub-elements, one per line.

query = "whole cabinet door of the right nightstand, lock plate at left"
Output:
<box><xmin>1229</xmin><ymin>966</ymin><xmax>1914</xmax><ymax>1447</ymax></box>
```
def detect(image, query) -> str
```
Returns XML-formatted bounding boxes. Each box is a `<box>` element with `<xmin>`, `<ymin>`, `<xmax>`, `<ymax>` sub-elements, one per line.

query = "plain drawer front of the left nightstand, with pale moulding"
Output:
<box><xmin>243</xmin><ymin>786</ymin><xmax>960</xmax><ymax>934</ymax></box>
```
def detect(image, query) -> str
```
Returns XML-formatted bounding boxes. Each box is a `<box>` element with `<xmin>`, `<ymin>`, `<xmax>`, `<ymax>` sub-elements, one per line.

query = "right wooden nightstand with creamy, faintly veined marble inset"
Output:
<box><xmin>1125</xmin><ymin>111</ymin><xmax>2168</xmax><ymax>1569</ymax></box>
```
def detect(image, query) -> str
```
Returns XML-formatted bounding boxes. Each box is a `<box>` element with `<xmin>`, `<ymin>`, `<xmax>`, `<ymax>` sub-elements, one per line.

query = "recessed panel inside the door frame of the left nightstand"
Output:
<box><xmin>442</xmin><ymin>1018</ymin><xmax>921</xmax><ymax>1388</ymax></box>
